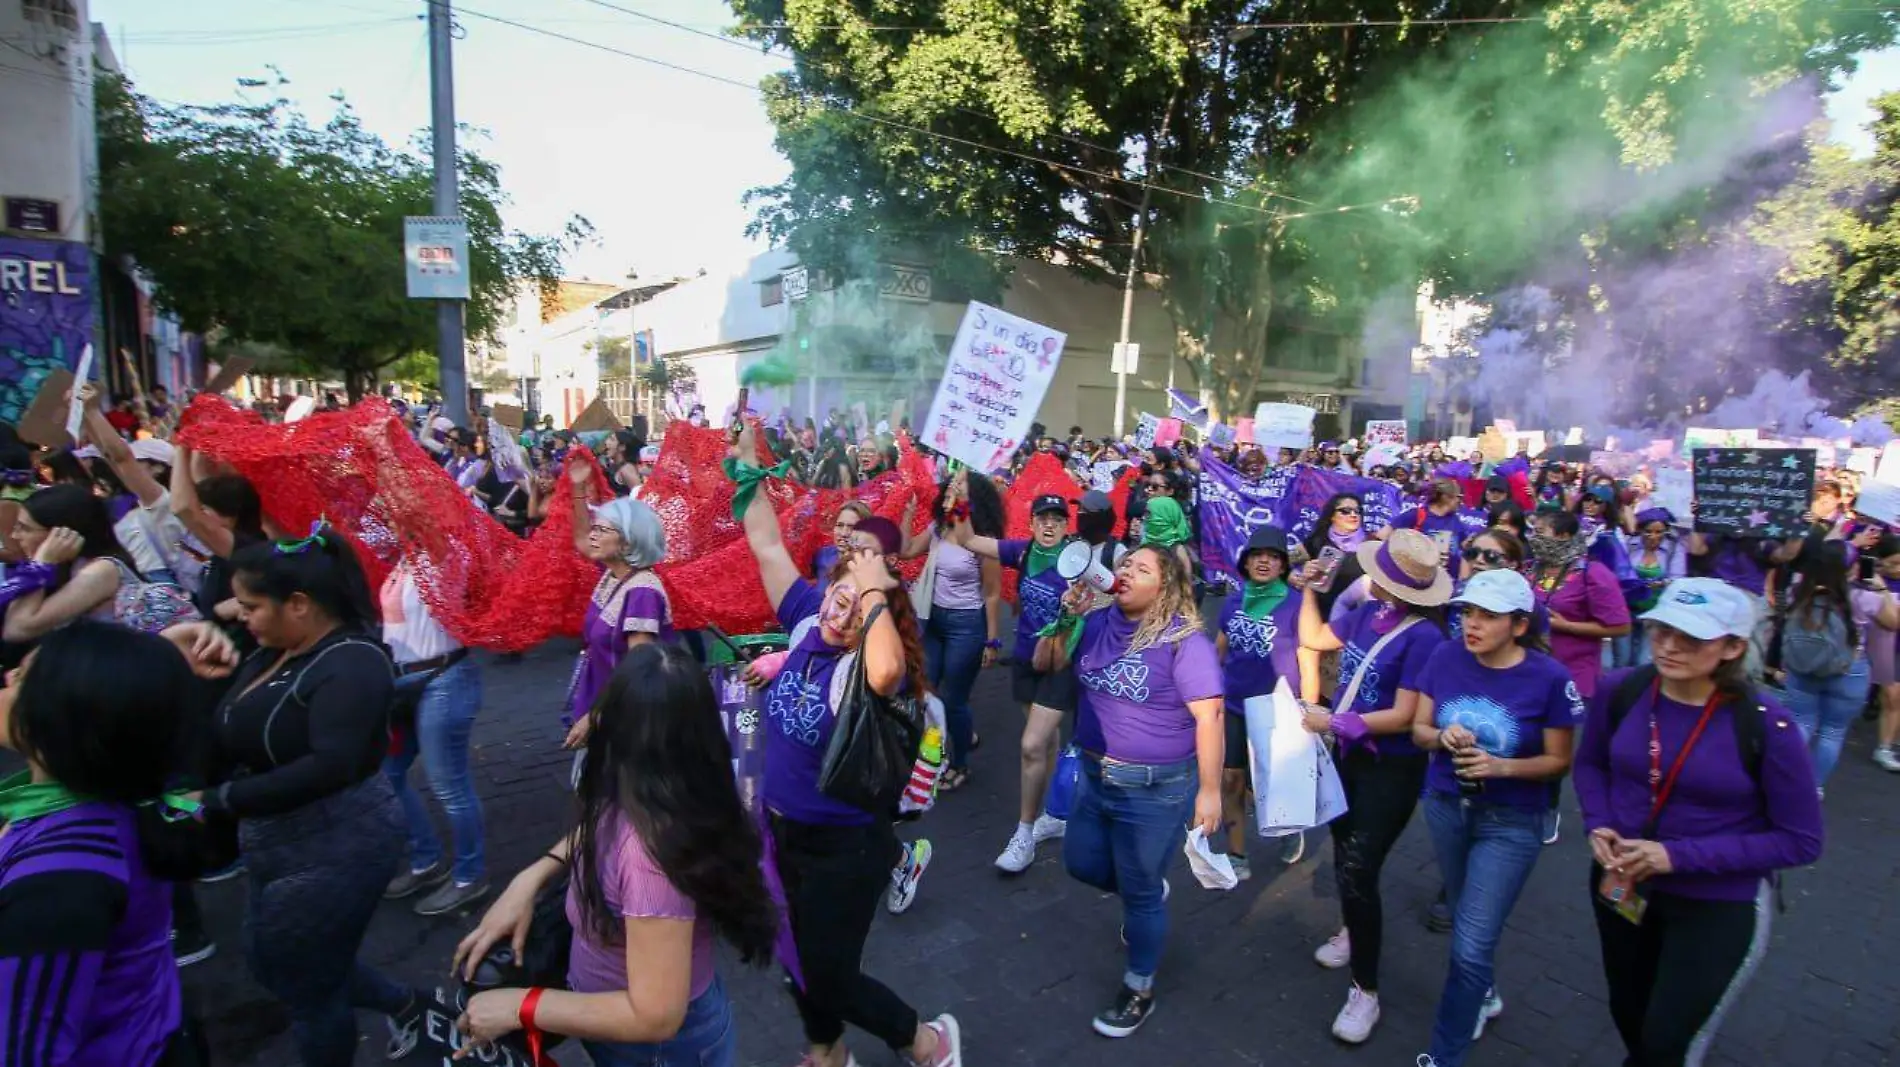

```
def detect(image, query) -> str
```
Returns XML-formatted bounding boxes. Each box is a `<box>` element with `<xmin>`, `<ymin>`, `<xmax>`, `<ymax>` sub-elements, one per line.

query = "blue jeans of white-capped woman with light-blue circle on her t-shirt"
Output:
<box><xmin>1421</xmin><ymin>794</ymin><xmax>1543</xmax><ymax>1067</ymax></box>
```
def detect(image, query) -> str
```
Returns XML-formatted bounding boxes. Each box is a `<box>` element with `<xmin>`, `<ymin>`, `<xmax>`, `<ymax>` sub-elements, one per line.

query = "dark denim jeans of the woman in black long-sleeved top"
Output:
<box><xmin>238</xmin><ymin>775</ymin><xmax>410</xmax><ymax>1067</ymax></box>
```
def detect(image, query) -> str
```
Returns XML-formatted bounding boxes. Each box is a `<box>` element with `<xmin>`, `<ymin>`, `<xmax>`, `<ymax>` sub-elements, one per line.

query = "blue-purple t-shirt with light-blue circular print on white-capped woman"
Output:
<box><xmin>1419</xmin><ymin>642</ymin><xmax>1585</xmax><ymax>811</ymax></box>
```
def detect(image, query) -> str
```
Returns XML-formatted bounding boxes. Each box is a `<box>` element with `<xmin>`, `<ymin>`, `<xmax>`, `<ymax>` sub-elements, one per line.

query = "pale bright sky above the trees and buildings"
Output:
<box><xmin>91</xmin><ymin>0</ymin><xmax>1900</xmax><ymax>281</ymax></box>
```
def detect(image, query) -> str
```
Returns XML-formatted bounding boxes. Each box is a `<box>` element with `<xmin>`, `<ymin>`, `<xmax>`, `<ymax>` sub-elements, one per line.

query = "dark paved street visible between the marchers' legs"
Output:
<box><xmin>186</xmin><ymin>642</ymin><xmax>1900</xmax><ymax>1067</ymax></box>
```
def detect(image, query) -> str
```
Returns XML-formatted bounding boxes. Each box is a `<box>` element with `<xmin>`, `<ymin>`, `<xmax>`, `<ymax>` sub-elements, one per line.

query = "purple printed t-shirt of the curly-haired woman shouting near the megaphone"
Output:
<box><xmin>1072</xmin><ymin>606</ymin><xmax>1222</xmax><ymax>763</ymax></box>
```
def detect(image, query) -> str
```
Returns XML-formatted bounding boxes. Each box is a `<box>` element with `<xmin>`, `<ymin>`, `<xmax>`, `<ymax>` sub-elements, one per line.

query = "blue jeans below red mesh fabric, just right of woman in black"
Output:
<box><xmin>382</xmin><ymin>657</ymin><xmax>486</xmax><ymax>885</ymax></box>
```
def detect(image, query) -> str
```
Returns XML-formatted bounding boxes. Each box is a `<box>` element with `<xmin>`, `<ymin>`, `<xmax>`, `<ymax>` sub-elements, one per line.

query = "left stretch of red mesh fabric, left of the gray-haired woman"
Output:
<box><xmin>177</xmin><ymin>397</ymin><xmax>606</xmax><ymax>651</ymax></box>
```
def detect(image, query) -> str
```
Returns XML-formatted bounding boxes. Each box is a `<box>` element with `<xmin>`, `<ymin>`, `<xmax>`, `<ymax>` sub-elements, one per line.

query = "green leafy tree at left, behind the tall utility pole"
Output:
<box><xmin>99</xmin><ymin>78</ymin><xmax>589</xmax><ymax>399</ymax></box>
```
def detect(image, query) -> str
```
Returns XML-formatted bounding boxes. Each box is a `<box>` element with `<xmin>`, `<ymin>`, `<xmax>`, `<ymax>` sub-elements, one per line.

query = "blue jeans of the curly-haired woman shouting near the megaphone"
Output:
<box><xmin>1062</xmin><ymin>756</ymin><xmax>1199</xmax><ymax>993</ymax></box>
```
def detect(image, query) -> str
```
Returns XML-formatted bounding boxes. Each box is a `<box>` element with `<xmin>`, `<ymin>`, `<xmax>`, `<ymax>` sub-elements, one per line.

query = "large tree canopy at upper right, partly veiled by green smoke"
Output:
<box><xmin>733</xmin><ymin>0</ymin><xmax>1900</xmax><ymax>423</ymax></box>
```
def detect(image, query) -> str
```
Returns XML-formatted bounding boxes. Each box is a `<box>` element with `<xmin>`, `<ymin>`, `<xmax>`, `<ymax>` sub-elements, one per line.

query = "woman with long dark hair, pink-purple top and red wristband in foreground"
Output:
<box><xmin>456</xmin><ymin>646</ymin><xmax>779</xmax><ymax>1067</ymax></box>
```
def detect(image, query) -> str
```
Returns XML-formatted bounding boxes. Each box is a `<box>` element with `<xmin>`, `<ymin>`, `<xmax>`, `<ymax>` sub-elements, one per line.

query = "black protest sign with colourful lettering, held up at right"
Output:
<box><xmin>1693</xmin><ymin>448</ymin><xmax>1815</xmax><ymax>539</ymax></box>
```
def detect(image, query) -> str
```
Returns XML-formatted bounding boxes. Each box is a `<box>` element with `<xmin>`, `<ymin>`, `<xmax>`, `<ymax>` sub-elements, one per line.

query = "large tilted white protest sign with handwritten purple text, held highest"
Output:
<box><xmin>923</xmin><ymin>300</ymin><xmax>1068</xmax><ymax>471</ymax></box>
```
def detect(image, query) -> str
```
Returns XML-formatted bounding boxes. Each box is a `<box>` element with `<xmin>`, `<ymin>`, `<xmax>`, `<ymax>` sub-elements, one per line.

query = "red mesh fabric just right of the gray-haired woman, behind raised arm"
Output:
<box><xmin>640</xmin><ymin>421</ymin><xmax>937</xmax><ymax>634</ymax></box>
